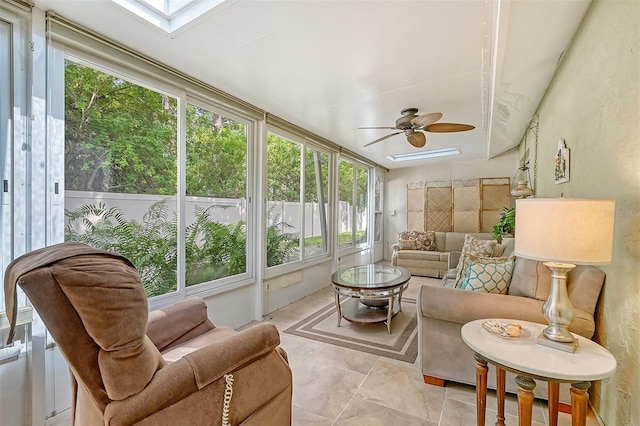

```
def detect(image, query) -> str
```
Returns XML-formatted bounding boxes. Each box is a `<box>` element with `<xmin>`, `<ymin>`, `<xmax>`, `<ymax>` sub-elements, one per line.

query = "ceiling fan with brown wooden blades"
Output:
<box><xmin>359</xmin><ymin>108</ymin><xmax>475</xmax><ymax>148</ymax></box>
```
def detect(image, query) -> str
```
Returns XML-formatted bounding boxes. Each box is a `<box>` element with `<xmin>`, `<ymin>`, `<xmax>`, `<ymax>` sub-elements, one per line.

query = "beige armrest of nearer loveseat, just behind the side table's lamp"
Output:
<box><xmin>418</xmin><ymin>285</ymin><xmax>595</xmax><ymax>338</ymax></box>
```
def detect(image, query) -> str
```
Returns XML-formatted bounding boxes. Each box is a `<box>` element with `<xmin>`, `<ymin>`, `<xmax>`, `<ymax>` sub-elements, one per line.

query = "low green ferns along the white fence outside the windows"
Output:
<box><xmin>65</xmin><ymin>200</ymin><xmax>299</xmax><ymax>297</ymax></box>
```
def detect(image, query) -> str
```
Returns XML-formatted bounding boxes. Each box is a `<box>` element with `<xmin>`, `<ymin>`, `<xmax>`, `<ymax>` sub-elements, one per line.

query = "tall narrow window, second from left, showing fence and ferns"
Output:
<box><xmin>185</xmin><ymin>103</ymin><xmax>248</xmax><ymax>286</ymax></box>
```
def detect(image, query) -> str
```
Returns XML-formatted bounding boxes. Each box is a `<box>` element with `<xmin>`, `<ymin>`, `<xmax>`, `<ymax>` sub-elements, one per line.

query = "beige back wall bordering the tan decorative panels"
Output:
<box><xmin>384</xmin><ymin>153</ymin><xmax>524</xmax><ymax>259</ymax></box>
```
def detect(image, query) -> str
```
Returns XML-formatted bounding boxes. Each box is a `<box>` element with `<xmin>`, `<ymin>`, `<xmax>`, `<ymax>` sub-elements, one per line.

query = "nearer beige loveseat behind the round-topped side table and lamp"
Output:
<box><xmin>418</xmin><ymin>235</ymin><xmax>605</xmax><ymax>404</ymax></box>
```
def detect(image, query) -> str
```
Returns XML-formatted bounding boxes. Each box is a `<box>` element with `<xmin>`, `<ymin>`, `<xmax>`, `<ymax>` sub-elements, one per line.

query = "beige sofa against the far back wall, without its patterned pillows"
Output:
<box><xmin>391</xmin><ymin>232</ymin><xmax>491</xmax><ymax>278</ymax></box>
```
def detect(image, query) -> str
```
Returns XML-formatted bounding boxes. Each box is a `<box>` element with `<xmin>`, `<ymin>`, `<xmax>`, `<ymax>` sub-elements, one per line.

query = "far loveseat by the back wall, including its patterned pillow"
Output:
<box><xmin>391</xmin><ymin>231</ymin><xmax>491</xmax><ymax>278</ymax></box>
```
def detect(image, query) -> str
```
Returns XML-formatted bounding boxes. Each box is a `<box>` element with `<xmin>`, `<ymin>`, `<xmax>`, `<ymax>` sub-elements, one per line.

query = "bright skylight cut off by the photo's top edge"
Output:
<box><xmin>112</xmin><ymin>0</ymin><xmax>224</xmax><ymax>33</ymax></box>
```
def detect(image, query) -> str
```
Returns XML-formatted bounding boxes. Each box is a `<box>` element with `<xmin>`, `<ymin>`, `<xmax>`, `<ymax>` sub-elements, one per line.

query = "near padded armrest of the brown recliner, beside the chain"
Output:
<box><xmin>105</xmin><ymin>323</ymin><xmax>290</xmax><ymax>425</ymax></box>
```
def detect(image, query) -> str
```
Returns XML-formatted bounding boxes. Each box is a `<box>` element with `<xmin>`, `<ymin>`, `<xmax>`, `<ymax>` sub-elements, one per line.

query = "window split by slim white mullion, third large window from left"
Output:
<box><xmin>266</xmin><ymin>133</ymin><xmax>329</xmax><ymax>267</ymax></box>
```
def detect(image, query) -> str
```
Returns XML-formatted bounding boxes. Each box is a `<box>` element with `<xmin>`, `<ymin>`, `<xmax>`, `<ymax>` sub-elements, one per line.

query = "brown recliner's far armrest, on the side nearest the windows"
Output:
<box><xmin>147</xmin><ymin>297</ymin><xmax>215</xmax><ymax>351</ymax></box>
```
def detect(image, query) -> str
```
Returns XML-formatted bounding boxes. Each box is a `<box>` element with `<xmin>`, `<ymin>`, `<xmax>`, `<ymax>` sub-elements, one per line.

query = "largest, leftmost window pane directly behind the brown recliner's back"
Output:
<box><xmin>65</xmin><ymin>60</ymin><xmax>178</xmax><ymax>297</ymax></box>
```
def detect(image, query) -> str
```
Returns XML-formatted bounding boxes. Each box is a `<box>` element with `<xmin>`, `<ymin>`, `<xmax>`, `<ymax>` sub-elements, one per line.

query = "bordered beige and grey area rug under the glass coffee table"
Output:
<box><xmin>284</xmin><ymin>298</ymin><xmax>418</xmax><ymax>363</ymax></box>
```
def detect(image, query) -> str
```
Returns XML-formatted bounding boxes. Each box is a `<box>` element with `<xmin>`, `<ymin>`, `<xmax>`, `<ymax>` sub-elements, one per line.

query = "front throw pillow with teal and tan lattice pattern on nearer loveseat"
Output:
<box><xmin>461</xmin><ymin>257</ymin><xmax>515</xmax><ymax>294</ymax></box>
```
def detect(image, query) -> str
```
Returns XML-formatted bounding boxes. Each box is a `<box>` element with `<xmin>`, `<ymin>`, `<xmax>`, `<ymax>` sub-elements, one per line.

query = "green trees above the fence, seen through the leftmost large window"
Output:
<box><xmin>65</xmin><ymin>61</ymin><xmax>177</xmax><ymax>195</ymax></box>
